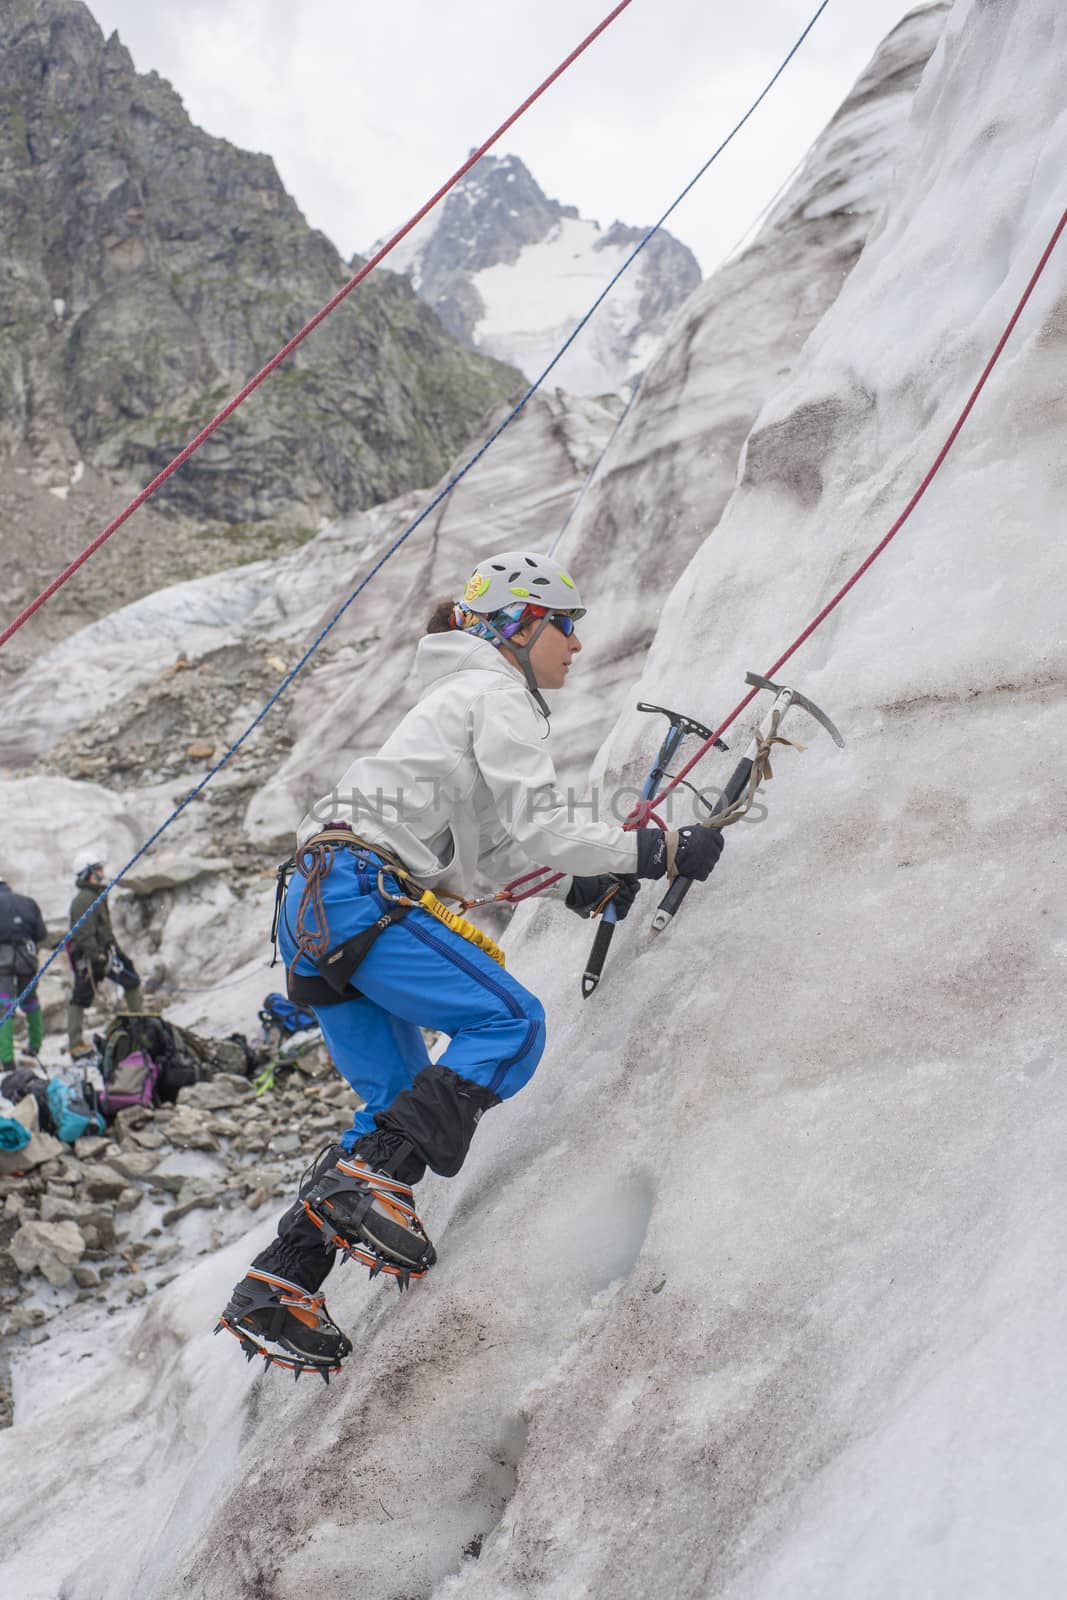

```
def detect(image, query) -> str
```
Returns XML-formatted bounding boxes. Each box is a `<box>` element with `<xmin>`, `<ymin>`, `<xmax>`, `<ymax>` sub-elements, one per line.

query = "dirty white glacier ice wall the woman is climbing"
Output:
<box><xmin>0</xmin><ymin>0</ymin><xmax>1067</xmax><ymax>1600</ymax></box>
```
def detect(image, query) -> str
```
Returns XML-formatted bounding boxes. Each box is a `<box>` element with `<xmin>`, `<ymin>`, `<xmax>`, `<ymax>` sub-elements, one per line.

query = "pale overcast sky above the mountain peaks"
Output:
<box><xmin>88</xmin><ymin>0</ymin><xmax>913</xmax><ymax>272</ymax></box>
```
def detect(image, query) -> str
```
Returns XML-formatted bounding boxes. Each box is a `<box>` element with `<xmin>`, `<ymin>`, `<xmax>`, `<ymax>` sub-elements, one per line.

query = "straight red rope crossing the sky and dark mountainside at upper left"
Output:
<box><xmin>0</xmin><ymin>0</ymin><xmax>632</xmax><ymax>645</ymax></box>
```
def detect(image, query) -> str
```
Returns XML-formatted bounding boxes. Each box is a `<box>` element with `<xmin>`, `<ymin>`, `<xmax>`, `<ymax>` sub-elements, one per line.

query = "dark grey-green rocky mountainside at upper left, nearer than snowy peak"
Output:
<box><xmin>0</xmin><ymin>0</ymin><xmax>518</xmax><ymax>656</ymax></box>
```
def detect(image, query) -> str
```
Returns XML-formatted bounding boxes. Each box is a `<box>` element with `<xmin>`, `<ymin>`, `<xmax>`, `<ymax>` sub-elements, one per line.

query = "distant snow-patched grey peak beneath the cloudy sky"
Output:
<box><xmin>382</xmin><ymin>155</ymin><xmax>701</xmax><ymax>395</ymax></box>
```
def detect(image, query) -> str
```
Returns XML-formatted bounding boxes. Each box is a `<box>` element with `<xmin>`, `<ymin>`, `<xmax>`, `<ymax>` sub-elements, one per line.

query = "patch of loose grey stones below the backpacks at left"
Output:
<box><xmin>0</xmin><ymin>1042</ymin><xmax>357</xmax><ymax>1426</ymax></box>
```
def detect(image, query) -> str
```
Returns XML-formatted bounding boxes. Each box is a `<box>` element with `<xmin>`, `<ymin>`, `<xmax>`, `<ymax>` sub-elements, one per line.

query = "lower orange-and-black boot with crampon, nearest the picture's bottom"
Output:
<box><xmin>214</xmin><ymin>1267</ymin><xmax>352</xmax><ymax>1384</ymax></box>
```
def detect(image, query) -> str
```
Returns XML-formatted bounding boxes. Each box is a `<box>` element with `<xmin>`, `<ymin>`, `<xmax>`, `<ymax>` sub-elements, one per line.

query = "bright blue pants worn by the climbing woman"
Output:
<box><xmin>278</xmin><ymin>848</ymin><xmax>545</xmax><ymax>1152</ymax></box>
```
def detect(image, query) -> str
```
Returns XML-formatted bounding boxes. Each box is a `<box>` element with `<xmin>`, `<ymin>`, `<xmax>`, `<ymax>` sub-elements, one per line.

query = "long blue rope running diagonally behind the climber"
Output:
<box><xmin>0</xmin><ymin>0</ymin><xmax>830</xmax><ymax>1022</ymax></box>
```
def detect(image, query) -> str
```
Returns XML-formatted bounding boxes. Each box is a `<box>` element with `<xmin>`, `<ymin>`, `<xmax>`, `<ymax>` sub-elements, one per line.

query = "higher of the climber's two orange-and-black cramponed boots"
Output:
<box><xmin>301</xmin><ymin>1131</ymin><xmax>437</xmax><ymax>1290</ymax></box>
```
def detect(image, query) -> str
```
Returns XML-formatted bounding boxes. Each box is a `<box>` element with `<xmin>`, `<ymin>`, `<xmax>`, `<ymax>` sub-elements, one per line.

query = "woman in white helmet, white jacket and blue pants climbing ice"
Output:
<box><xmin>216</xmin><ymin>552</ymin><xmax>723</xmax><ymax>1381</ymax></box>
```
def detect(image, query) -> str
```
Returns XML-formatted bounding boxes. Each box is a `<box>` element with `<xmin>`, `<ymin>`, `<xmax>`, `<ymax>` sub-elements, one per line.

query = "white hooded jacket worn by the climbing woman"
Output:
<box><xmin>298</xmin><ymin>632</ymin><xmax>637</xmax><ymax>896</ymax></box>
